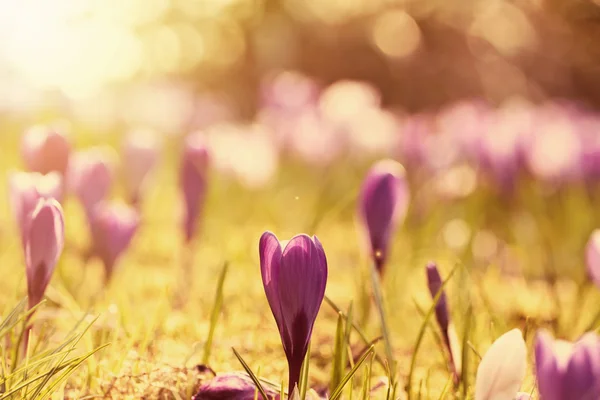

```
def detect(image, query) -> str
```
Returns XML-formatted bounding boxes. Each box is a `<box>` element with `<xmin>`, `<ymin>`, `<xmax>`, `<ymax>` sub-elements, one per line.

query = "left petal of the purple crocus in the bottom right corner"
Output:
<box><xmin>535</xmin><ymin>331</ymin><xmax>563</xmax><ymax>400</ymax></box>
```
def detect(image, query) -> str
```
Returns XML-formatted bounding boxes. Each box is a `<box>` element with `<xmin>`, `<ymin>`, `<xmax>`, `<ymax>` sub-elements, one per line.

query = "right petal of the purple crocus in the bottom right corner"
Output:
<box><xmin>563</xmin><ymin>334</ymin><xmax>600</xmax><ymax>400</ymax></box>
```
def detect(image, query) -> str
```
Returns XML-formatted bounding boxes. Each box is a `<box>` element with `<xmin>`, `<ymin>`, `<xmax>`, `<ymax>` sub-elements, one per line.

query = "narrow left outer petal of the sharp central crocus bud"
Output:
<box><xmin>258</xmin><ymin>232</ymin><xmax>283</xmax><ymax>332</ymax></box>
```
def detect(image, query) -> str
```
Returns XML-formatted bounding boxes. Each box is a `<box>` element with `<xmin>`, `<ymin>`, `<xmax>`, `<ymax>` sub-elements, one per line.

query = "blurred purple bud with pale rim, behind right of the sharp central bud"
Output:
<box><xmin>358</xmin><ymin>160</ymin><xmax>410</xmax><ymax>274</ymax></box>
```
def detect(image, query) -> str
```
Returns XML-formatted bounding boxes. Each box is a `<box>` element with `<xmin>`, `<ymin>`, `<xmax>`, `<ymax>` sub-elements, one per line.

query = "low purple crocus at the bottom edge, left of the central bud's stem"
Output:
<box><xmin>192</xmin><ymin>372</ymin><xmax>279</xmax><ymax>400</ymax></box>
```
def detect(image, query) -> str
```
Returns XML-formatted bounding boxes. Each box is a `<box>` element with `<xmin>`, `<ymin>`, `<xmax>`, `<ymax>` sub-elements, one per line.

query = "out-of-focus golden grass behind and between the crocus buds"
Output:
<box><xmin>0</xmin><ymin>123</ymin><xmax>600</xmax><ymax>399</ymax></box>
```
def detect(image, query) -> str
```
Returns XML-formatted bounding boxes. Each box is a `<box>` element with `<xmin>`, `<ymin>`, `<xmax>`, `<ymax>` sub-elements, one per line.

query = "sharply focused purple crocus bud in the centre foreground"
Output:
<box><xmin>259</xmin><ymin>232</ymin><xmax>327</xmax><ymax>393</ymax></box>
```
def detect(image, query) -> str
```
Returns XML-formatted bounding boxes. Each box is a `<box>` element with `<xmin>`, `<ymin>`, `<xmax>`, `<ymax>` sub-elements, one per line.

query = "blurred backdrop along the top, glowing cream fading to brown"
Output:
<box><xmin>0</xmin><ymin>0</ymin><xmax>600</xmax><ymax>133</ymax></box>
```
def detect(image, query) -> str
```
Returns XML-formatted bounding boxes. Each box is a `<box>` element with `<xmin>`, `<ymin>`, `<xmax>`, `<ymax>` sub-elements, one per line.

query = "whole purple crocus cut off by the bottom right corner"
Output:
<box><xmin>535</xmin><ymin>331</ymin><xmax>600</xmax><ymax>400</ymax></box>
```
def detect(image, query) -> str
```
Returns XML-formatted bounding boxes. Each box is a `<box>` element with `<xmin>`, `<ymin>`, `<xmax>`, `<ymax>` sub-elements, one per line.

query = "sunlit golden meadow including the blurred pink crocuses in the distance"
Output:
<box><xmin>0</xmin><ymin>84</ymin><xmax>600</xmax><ymax>400</ymax></box>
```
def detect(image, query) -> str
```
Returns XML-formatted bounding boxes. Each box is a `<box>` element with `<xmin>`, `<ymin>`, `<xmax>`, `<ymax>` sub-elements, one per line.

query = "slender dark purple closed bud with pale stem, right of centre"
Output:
<box><xmin>426</xmin><ymin>263</ymin><xmax>462</xmax><ymax>383</ymax></box>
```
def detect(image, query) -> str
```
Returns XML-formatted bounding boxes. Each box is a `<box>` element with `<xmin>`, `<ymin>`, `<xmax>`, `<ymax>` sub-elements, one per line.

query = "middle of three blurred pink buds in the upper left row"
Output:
<box><xmin>68</xmin><ymin>147</ymin><xmax>116</xmax><ymax>215</ymax></box>
